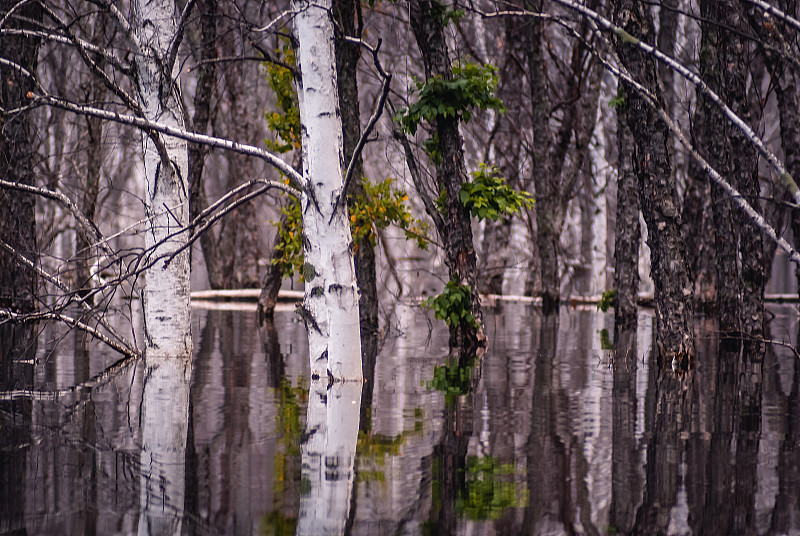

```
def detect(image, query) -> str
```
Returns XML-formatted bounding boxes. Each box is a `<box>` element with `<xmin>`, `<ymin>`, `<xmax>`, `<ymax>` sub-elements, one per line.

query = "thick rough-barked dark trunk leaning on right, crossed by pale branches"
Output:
<box><xmin>614</xmin><ymin>0</ymin><xmax>694</xmax><ymax>360</ymax></box>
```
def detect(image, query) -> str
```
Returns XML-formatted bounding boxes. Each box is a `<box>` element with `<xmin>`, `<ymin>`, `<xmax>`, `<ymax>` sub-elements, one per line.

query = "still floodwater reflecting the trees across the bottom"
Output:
<box><xmin>0</xmin><ymin>304</ymin><xmax>800</xmax><ymax>536</ymax></box>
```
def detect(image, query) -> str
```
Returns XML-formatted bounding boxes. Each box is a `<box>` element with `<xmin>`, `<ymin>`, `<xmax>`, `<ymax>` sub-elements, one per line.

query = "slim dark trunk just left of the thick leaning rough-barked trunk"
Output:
<box><xmin>614</xmin><ymin>109</ymin><xmax>642</xmax><ymax>328</ymax></box>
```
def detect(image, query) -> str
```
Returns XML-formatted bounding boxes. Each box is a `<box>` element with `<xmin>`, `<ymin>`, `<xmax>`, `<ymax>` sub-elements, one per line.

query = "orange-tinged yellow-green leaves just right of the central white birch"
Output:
<box><xmin>350</xmin><ymin>178</ymin><xmax>428</xmax><ymax>249</ymax></box>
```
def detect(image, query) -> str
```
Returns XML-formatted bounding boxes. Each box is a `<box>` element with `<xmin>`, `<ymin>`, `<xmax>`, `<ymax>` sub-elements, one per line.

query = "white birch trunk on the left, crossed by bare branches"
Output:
<box><xmin>131</xmin><ymin>0</ymin><xmax>192</xmax><ymax>357</ymax></box>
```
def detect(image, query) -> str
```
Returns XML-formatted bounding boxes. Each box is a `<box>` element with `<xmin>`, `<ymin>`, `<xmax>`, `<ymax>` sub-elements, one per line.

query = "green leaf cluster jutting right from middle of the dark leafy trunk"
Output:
<box><xmin>459</xmin><ymin>164</ymin><xmax>534</xmax><ymax>220</ymax></box>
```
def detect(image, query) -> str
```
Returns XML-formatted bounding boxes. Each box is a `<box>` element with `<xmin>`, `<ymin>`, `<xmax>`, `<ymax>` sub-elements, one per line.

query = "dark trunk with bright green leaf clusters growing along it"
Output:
<box><xmin>411</xmin><ymin>0</ymin><xmax>486</xmax><ymax>352</ymax></box>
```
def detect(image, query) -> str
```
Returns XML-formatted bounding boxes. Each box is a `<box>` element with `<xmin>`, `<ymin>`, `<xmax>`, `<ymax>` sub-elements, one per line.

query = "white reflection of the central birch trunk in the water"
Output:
<box><xmin>297</xmin><ymin>382</ymin><xmax>362</xmax><ymax>535</ymax></box>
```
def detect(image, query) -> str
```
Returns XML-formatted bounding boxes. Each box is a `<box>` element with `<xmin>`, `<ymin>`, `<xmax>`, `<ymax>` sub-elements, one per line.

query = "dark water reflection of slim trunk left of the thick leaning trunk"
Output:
<box><xmin>609</xmin><ymin>325</ymin><xmax>642</xmax><ymax>534</ymax></box>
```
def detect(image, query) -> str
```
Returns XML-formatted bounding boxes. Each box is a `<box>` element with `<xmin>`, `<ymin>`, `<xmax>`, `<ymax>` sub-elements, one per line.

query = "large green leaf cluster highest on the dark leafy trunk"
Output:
<box><xmin>396</xmin><ymin>63</ymin><xmax>505</xmax><ymax>134</ymax></box>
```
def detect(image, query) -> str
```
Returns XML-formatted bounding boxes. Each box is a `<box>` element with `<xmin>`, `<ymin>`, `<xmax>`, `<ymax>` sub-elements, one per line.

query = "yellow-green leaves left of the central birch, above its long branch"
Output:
<box><xmin>265</xmin><ymin>40</ymin><xmax>301</xmax><ymax>153</ymax></box>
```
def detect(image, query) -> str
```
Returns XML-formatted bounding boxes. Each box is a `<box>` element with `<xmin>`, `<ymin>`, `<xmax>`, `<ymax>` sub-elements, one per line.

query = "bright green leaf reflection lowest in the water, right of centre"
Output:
<box><xmin>456</xmin><ymin>456</ymin><xmax>528</xmax><ymax>520</ymax></box>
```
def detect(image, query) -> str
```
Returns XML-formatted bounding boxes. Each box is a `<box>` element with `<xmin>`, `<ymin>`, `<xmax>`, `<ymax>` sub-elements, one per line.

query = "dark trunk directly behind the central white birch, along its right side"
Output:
<box><xmin>333</xmin><ymin>0</ymin><xmax>378</xmax><ymax>346</ymax></box>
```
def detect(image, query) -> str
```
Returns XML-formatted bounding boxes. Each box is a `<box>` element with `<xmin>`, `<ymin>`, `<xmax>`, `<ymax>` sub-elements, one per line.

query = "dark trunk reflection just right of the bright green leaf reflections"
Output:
<box><xmin>523</xmin><ymin>315</ymin><xmax>576</xmax><ymax>534</ymax></box>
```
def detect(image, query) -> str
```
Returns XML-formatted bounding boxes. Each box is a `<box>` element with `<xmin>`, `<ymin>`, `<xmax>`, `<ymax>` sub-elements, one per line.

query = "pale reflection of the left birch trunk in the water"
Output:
<box><xmin>139</xmin><ymin>357</ymin><xmax>192</xmax><ymax>535</ymax></box>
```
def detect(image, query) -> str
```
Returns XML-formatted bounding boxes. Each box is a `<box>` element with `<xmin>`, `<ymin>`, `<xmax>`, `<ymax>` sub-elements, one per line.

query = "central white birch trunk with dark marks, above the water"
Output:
<box><xmin>292</xmin><ymin>0</ymin><xmax>363</xmax><ymax>381</ymax></box>
